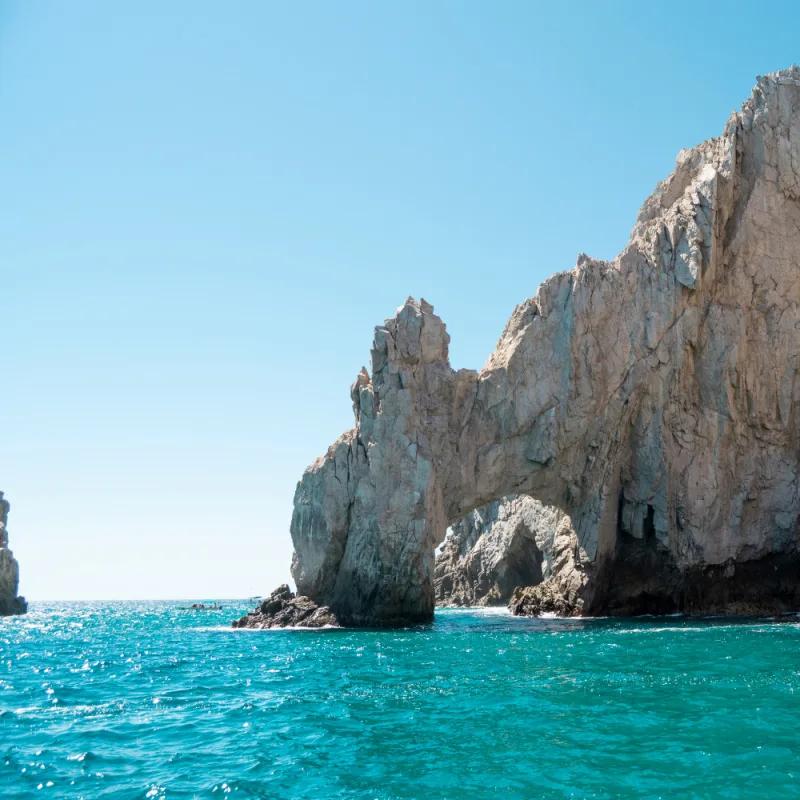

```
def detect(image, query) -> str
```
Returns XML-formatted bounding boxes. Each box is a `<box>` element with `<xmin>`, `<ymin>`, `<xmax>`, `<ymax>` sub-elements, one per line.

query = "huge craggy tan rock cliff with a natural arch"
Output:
<box><xmin>291</xmin><ymin>67</ymin><xmax>800</xmax><ymax>624</ymax></box>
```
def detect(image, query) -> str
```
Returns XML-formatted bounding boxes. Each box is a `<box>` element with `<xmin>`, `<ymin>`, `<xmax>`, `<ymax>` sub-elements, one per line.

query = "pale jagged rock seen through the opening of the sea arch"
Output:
<box><xmin>434</xmin><ymin>495</ymin><xmax>589</xmax><ymax>606</ymax></box>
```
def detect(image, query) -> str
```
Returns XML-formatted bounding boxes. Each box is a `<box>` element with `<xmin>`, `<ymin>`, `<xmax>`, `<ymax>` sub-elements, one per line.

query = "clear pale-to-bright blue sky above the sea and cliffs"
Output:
<box><xmin>0</xmin><ymin>0</ymin><xmax>800</xmax><ymax>599</ymax></box>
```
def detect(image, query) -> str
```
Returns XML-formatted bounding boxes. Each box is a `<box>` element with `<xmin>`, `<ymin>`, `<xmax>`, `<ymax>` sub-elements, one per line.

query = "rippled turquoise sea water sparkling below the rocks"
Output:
<box><xmin>0</xmin><ymin>602</ymin><xmax>800</xmax><ymax>800</ymax></box>
